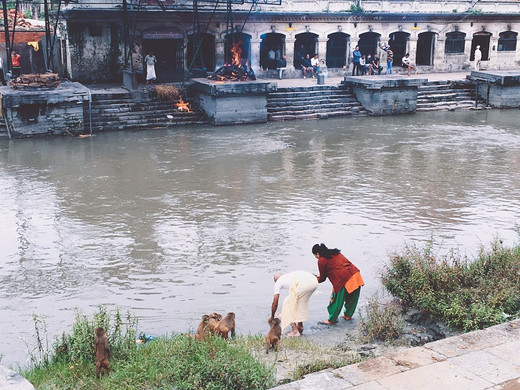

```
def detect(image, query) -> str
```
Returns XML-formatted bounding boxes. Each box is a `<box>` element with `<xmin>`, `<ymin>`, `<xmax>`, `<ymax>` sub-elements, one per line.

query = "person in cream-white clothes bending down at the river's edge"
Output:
<box><xmin>271</xmin><ymin>271</ymin><xmax>318</xmax><ymax>337</ymax></box>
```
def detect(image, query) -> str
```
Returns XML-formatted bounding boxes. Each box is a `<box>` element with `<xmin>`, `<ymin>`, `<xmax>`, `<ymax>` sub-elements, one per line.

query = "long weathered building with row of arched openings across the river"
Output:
<box><xmin>55</xmin><ymin>0</ymin><xmax>520</xmax><ymax>82</ymax></box>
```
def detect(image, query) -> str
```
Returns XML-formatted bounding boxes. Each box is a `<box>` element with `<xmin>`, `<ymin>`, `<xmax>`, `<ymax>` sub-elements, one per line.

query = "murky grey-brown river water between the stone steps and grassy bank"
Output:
<box><xmin>0</xmin><ymin>110</ymin><xmax>520</xmax><ymax>364</ymax></box>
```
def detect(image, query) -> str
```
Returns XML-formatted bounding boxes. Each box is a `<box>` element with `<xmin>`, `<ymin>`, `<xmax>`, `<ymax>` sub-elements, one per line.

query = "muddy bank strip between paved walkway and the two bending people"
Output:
<box><xmin>255</xmin><ymin>310</ymin><xmax>461</xmax><ymax>384</ymax></box>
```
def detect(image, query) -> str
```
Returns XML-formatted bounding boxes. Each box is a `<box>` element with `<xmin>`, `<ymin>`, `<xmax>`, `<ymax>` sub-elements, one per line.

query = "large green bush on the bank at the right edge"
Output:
<box><xmin>382</xmin><ymin>240</ymin><xmax>520</xmax><ymax>331</ymax></box>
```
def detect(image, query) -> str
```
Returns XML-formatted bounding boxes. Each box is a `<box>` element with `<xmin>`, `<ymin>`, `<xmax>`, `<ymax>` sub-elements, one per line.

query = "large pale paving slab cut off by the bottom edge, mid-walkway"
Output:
<box><xmin>378</xmin><ymin>361</ymin><xmax>493</xmax><ymax>390</ymax></box>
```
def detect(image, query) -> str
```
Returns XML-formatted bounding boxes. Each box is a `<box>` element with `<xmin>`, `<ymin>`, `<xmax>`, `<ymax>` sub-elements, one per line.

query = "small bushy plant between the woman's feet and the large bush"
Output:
<box><xmin>359</xmin><ymin>295</ymin><xmax>404</xmax><ymax>342</ymax></box>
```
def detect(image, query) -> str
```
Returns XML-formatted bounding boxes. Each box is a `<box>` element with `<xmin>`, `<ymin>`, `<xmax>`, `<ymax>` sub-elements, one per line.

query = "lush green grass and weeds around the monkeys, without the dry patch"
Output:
<box><xmin>21</xmin><ymin>307</ymin><xmax>274</xmax><ymax>390</ymax></box>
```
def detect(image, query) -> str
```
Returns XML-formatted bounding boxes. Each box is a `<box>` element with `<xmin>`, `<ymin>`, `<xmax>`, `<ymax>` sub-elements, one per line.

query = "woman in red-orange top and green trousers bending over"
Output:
<box><xmin>312</xmin><ymin>244</ymin><xmax>365</xmax><ymax>325</ymax></box>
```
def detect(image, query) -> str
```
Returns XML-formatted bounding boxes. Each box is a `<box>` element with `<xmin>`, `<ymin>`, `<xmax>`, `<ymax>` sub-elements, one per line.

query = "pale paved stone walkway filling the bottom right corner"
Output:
<box><xmin>275</xmin><ymin>320</ymin><xmax>520</xmax><ymax>390</ymax></box>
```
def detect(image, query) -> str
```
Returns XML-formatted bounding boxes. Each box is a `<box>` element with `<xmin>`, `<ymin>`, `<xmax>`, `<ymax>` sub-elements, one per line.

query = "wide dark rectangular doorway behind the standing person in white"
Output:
<box><xmin>143</xmin><ymin>39</ymin><xmax>184</xmax><ymax>83</ymax></box>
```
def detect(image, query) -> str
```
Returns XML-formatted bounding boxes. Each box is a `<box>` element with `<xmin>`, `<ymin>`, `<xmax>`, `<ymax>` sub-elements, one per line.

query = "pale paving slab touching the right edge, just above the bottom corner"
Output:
<box><xmin>450</xmin><ymin>351</ymin><xmax>520</xmax><ymax>385</ymax></box>
